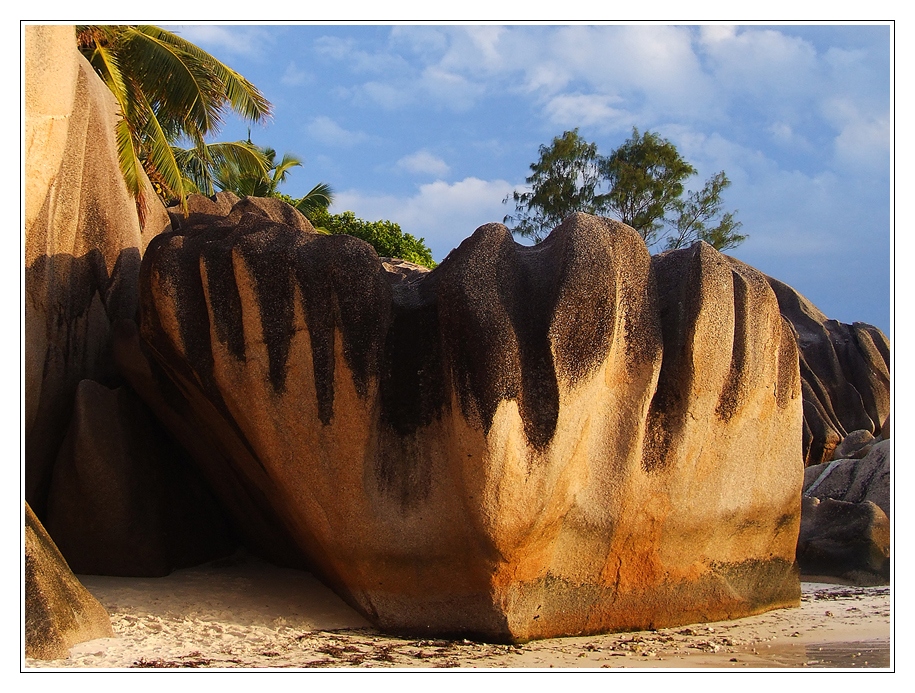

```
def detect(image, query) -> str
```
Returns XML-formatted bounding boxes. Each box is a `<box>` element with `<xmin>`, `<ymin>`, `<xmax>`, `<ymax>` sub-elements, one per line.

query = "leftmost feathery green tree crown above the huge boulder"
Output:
<box><xmin>503</xmin><ymin>128</ymin><xmax>600</xmax><ymax>243</ymax></box>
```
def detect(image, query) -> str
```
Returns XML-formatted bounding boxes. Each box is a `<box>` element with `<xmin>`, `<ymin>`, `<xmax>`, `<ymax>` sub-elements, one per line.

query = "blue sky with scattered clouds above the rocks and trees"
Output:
<box><xmin>169</xmin><ymin>24</ymin><xmax>892</xmax><ymax>336</ymax></box>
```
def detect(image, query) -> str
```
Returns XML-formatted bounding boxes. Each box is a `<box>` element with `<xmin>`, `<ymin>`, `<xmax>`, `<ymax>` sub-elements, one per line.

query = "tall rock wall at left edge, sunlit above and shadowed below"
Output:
<box><xmin>25</xmin><ymin>26</ymin><xmax>168</xmax><ymax>517</ymax></box>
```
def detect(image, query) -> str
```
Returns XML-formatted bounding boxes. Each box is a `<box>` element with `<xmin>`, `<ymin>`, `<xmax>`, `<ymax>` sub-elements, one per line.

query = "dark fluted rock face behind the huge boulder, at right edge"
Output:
<box><xmin>767</xmin><ymin>277</ymin><xmax>890</xmax><ymax>466</ymax></box>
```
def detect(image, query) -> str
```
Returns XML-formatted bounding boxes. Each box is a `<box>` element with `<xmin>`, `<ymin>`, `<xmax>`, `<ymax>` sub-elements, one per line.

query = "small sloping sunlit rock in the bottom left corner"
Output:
<box><xmin>25</xmin><ymin>503</ymin><xmax>114</xmax><ymax>659</ymax></box>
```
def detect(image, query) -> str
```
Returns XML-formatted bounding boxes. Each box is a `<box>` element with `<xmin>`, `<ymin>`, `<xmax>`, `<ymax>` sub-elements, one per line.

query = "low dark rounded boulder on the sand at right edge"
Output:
<box><xmin>797</xmin><ymin>497</ymin><xmax>890</xmax><ymax>585</ymax></box>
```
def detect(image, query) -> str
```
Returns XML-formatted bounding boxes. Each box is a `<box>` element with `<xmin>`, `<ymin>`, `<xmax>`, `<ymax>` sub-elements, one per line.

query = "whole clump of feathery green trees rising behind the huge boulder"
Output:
<box><xmin>503</xmin><ymin>128</ymin><xmax>747</xmax><ymax>250</ymax></box>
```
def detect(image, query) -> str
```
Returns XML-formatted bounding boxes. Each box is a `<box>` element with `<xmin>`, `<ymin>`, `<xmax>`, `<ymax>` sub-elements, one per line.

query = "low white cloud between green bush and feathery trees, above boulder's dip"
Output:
<box><xmin>331</xmin><ymin>178</ymin><xmax>515</xmax><ymax>261</ymax></box>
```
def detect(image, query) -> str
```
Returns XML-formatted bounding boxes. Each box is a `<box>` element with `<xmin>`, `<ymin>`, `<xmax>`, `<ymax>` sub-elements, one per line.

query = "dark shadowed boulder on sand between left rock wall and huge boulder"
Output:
<box><xmin>45</xmin><ymin>380</ymin><xmax>237</xmax><ymax>577</ymax></box>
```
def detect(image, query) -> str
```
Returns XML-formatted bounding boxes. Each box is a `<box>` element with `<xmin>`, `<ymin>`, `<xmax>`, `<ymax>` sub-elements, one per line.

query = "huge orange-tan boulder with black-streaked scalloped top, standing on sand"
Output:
<box><xmin>136</xmin><ymin>212</ymin><xmax>803</xmax><ymax>641</ymax></box>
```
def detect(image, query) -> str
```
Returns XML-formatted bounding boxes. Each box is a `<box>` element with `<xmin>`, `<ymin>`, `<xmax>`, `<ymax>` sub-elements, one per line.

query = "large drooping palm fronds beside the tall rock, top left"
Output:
<box><xmin>76</xmin><ymin>25</ymin><xmax>271</xmax><ymax>217</ymax></box>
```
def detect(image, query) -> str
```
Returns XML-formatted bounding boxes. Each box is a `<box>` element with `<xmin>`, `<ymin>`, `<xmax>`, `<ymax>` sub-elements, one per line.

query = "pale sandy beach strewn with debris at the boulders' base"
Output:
<box><xmin>24</xmin><ymin>554</ymin><xmax>893</xmax><ymax>671</ymax></box>
